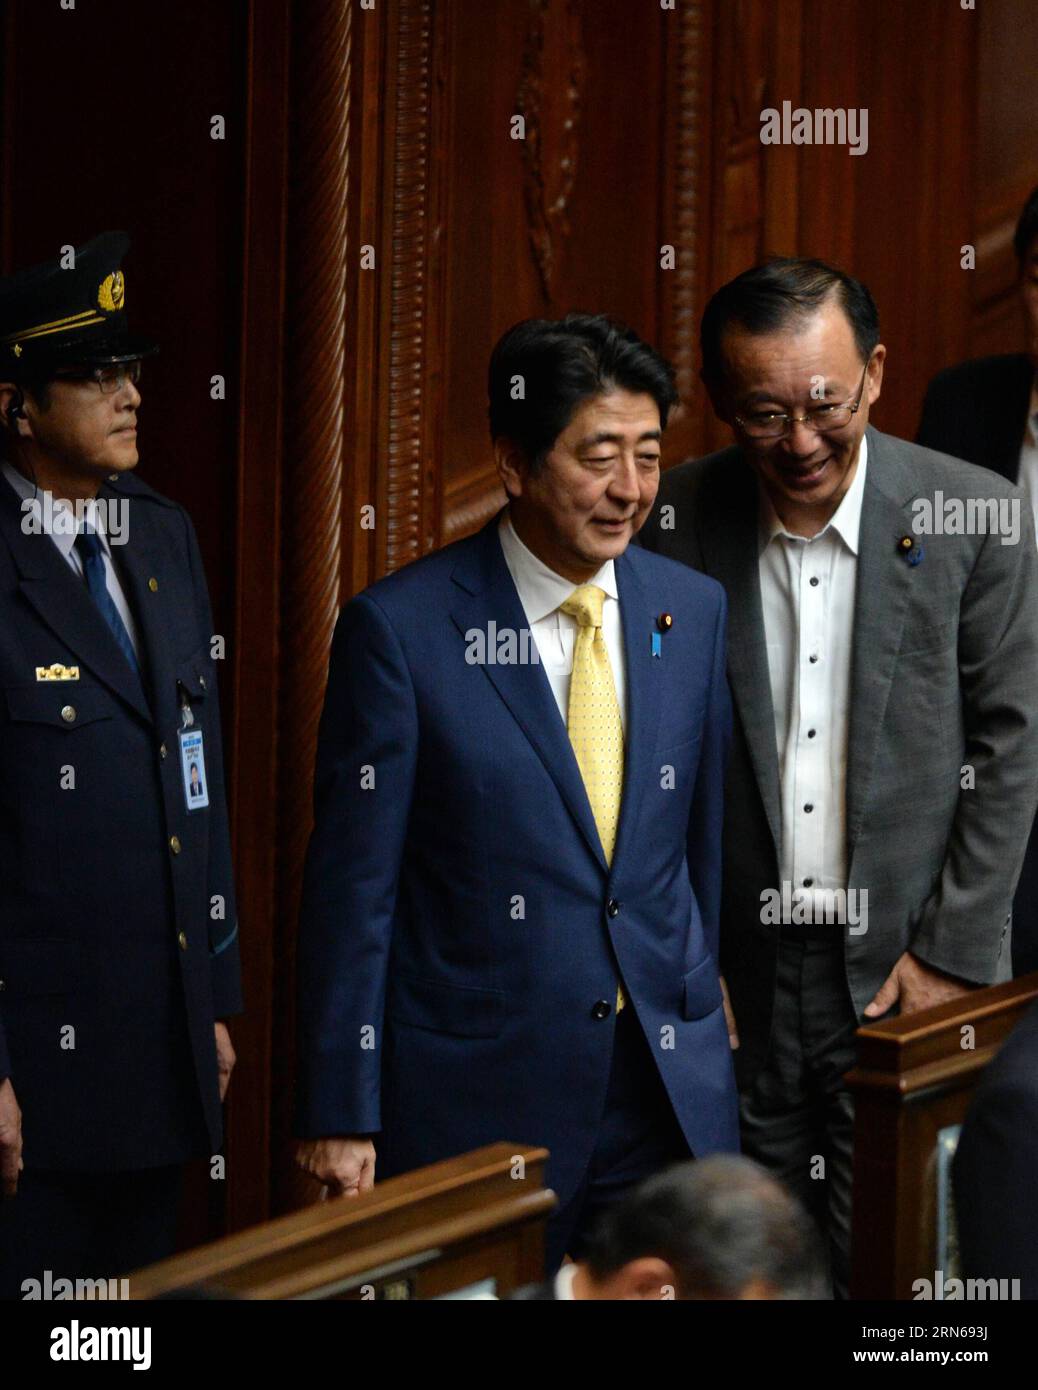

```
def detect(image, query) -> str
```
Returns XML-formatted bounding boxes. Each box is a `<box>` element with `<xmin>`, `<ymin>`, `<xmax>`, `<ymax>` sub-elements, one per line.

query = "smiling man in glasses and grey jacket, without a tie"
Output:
<box><xmin>642</xmin><ymin>260</ymin><xmax>1038</xmax><ymax>1294</ymax></box>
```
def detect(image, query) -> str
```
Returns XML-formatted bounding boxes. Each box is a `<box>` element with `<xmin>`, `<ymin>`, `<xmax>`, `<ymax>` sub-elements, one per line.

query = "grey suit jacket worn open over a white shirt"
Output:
<box><xmin>639</xmin><ymin>427</ymin><xmax>1038</xmax><ymax>1086</ymax></box>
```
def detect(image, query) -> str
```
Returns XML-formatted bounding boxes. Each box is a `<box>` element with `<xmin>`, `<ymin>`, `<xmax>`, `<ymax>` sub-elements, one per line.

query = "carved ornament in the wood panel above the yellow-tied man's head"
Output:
<box><xmin>516</xmin><ymin>0</ymin><xmax>586</xmax><ymax>300</ymax></box>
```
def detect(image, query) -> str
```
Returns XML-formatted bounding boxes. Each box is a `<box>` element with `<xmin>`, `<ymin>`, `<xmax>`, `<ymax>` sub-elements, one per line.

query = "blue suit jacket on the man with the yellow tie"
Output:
<box><xmin>297</xmin><ymin>520</ymin><xmax>738</xmax><ymax>1201</ymax></box>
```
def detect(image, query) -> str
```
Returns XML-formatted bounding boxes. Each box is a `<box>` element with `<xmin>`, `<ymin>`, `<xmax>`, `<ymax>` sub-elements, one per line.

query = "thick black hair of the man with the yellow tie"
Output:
<box><xmin>486</xmin><ymin>314</ymin><xmax>678</xmax><ymax>471</ymax></box>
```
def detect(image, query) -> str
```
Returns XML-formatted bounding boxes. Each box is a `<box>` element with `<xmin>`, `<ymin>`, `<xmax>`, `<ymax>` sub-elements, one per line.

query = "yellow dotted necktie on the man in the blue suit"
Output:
<box><xmin>560</xmin><ymin>584</ymin><xmax>624</xmax><ymax>1013</ymax></box>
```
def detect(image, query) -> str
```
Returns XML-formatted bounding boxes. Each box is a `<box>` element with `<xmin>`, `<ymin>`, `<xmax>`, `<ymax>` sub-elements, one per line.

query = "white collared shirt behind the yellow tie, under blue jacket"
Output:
<box><xmin>497</xmin><ymin>512</ymin><xmax>627</xmax><ymax>730</ymax></box>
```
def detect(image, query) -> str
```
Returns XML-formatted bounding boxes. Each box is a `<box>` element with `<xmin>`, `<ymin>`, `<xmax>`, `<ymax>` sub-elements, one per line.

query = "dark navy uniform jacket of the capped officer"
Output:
<box><xmin>0</xmin><ymin>475</ymin><xmax>240</xmax><ymax>1172</ymax></box>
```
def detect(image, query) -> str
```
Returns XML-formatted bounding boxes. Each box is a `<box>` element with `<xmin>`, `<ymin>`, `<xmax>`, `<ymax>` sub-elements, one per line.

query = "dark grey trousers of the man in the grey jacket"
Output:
<box><xmin>736</xmin><ymin>926</ymin><xmax>859</xmax><ymax>1298</ymax></box>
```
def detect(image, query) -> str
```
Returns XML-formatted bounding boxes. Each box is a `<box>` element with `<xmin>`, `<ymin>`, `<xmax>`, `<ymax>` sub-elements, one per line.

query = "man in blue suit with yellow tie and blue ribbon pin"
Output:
<box><xmin>297</xmin><ymin>314</ymin><xmax>738</xmax><ymax>1269</ymax></box>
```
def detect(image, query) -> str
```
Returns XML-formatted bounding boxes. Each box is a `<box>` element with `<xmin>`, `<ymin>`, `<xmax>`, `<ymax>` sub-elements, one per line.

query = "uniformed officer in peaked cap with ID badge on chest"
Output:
<box><xmin>0</xmin><ymin>232</ymin><xmax>240</xmax><ymax>1298</ymax></box>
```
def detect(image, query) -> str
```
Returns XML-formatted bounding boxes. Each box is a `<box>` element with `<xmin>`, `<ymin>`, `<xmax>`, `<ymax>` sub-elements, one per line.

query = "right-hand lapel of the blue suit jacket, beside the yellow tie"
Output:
<box><xmin>613</xmin><ymin>555</ymin><xmax>664</xmax><ymax>865</ymax></box>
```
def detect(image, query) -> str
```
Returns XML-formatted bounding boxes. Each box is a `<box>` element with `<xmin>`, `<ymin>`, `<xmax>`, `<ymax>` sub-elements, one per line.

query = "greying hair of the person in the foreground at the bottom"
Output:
<box><xmin>586</xmin><ymin>1154</ymin><xmax>823</xmax><ymax>1298</ymax></box>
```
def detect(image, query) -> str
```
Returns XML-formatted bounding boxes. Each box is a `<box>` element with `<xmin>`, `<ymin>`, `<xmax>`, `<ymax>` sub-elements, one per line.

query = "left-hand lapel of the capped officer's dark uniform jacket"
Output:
<box><xmin>0</xmin><ymin>480</ymin><xmax>151</xmax><ymax>721</ymax></box>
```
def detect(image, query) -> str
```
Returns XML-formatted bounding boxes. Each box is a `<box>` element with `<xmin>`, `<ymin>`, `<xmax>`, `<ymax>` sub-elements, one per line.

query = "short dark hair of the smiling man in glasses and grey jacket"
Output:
<box><xmin>699</xmin><ymin>256</ymin><xmax>880</xmax><ymax>382</ymax></box>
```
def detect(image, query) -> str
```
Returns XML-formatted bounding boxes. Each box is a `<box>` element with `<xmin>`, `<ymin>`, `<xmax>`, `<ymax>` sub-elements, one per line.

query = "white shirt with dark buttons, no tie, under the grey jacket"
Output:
<box><xmin>759</xmin><ymin>438</ymin><xmax>868</xmax><ymax>920</ymax></box>
